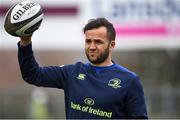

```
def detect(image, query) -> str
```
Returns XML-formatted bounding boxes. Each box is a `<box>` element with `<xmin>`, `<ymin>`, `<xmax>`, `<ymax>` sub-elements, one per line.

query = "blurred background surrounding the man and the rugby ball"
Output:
<box><xmin>0</xmin><ymin>0</ymin><xmax>180</xmax><ymax>119</ymax></box>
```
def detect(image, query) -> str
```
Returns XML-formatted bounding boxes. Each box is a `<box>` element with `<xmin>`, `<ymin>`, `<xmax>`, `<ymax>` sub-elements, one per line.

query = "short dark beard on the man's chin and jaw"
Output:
<box><xmin>85</xmin><ymin>47</ymin><xmax>109</xmax><ymax>64</ymax></box>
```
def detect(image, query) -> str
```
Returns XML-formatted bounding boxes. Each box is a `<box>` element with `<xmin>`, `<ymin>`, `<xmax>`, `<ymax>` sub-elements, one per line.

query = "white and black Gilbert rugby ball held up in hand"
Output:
<box><xmin>4</xmin><ymin>0</ymin><xmax>43</xmax><ymax>37</ymax></box>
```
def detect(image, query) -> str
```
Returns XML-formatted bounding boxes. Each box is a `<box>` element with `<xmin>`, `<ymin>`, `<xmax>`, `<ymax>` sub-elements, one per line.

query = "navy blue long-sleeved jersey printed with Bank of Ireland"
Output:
<box><xmin>18</xmin><ymin>44</ymin><xmax>147</xmax><ymax>119</ymax></box>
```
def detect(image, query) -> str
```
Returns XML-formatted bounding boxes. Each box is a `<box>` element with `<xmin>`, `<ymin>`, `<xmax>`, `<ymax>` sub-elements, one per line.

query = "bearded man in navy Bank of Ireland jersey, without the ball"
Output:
<box><xmin>18</xmin><ymin>18</ymin><xmax>147</xmax><ymax>119</ymax></box>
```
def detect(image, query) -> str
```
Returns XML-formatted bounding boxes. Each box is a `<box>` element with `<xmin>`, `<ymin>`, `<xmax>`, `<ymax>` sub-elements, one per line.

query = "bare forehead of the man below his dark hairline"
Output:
<box><xmin>85</xmin><ymin>27</ymin><xmax>107</xmax><ymax>38</ymax></box>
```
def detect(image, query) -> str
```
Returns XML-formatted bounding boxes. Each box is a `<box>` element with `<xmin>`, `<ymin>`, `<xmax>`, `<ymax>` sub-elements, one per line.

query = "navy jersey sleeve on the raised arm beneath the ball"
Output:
<box><xmin>18</xmin><ymin>43</ymin><xmax>66</xmax><ymax>89</ymax></box>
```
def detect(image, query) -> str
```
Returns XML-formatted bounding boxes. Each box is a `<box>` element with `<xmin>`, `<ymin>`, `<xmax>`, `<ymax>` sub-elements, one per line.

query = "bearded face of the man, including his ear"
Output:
<box><xmin>85</xmin><ymin>27</ymin><xmax>114</xmax><ymax>65</ymax></box>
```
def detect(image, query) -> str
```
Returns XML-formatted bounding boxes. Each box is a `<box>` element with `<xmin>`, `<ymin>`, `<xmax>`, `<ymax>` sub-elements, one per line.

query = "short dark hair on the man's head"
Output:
<box><xmin>83</xmin><ymin>18</ymin><xmax>116</xmax><ymax>41</ymax></box>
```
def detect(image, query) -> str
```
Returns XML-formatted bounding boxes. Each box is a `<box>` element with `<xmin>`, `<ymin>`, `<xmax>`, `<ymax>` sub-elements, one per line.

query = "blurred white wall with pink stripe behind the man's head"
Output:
<box><xmin>0</xmin><ymin>0</ymin><xmax>180</xmax><ymax>50</ymax></box>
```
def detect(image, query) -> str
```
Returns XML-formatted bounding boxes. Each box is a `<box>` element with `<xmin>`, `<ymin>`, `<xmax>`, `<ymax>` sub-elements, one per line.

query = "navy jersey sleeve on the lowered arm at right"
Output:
<box><xmin>126</xmin><ymin>76</ymin><xmax>148</xmax><ymax>119</ymax></box>
